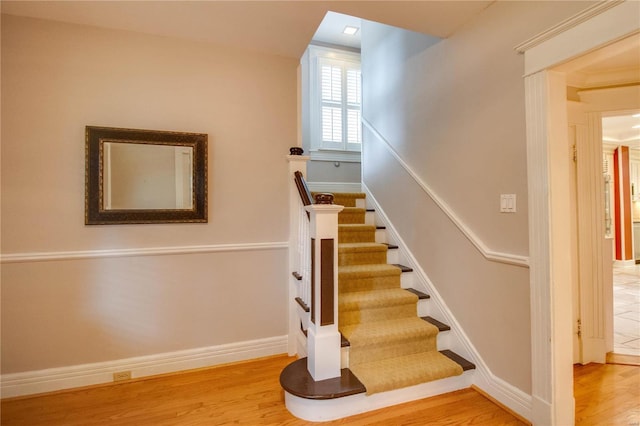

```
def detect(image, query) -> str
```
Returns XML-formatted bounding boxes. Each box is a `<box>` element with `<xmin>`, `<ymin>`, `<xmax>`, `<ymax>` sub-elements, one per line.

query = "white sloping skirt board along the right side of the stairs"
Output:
<box><xmin>362</xmin><ymin>182</ymin><xmax>532</xmax><ymax>419</ymax></box>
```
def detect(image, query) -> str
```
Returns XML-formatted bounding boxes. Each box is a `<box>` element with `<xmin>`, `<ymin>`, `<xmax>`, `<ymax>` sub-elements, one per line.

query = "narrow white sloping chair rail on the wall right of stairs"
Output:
<box><xmin>362</xmin><ymin>118</ymin><xmax>529</xmax><ymax>268</ymax></box>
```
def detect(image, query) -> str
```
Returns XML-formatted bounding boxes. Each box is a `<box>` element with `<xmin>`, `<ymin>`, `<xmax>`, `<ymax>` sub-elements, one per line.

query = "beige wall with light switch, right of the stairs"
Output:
<box><xmin>362</xmin><ymin>2</ymin><xmax>586</xmax><ymax>393</ymax></box>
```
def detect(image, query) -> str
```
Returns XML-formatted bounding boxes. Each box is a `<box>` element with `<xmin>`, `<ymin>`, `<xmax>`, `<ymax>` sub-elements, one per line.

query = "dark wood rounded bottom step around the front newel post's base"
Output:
<box><xmin>280</xmin><ymin>358</ymin><xmax>367</xmax><ymax>399</ymax></box>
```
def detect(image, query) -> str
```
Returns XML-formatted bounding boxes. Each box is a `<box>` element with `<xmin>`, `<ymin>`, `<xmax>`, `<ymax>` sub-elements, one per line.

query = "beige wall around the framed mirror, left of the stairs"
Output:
<box><xmin>1</xmin><ymin>15</ymin><xmax>297</xmax><ymax>374</ymax></box>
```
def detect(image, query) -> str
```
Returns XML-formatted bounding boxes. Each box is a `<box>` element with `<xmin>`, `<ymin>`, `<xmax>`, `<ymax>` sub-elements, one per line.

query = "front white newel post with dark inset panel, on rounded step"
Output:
<box><xmin>306</xmin><ymin>194</ymin><xmax>344</xmax><ymax>381</ymax></box>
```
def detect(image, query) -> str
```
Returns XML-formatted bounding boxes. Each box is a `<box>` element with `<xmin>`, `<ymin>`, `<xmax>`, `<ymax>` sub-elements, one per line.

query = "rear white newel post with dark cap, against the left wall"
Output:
<box><xmin>287</xmin><ymin>147</ymin><xmax>309</xmax><ymax>356</ymax></box>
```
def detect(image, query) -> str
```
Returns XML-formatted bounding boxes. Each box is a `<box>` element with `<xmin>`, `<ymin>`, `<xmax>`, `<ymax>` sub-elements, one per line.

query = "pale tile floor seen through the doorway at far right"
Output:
<box><xmin>613</xmin><ymin>265</ymin><xmax>640</xmax><ymax>356</ymax></box>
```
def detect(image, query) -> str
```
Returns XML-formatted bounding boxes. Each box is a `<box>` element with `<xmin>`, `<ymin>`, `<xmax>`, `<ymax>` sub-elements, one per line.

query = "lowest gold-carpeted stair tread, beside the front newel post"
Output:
<box><xmin>349</xmin><ymin>351</ymin><xmax>463</xmax><ymax>394</ymax></box>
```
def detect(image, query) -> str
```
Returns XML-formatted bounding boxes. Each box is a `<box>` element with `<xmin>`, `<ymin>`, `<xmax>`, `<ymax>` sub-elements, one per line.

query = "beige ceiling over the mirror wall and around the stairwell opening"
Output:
<box><xmin>0</xmin><ymin>0</ymin><xmax>494</xmax><ymax>59</ymax></box>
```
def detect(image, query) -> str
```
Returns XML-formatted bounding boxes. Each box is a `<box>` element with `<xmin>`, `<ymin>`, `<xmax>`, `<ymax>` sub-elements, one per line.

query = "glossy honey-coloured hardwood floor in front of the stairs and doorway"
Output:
<box><xmin>1</xmin><ymin>356</ymin><xmax>640</xmax><ymax>426</ymax></box>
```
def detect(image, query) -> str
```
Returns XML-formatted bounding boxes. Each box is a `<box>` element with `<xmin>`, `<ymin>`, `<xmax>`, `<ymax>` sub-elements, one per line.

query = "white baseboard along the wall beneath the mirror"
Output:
<box><xmin>0</xmin><ymin>336</ymin><xmax>287</xmax><ymax>398</ymax></box>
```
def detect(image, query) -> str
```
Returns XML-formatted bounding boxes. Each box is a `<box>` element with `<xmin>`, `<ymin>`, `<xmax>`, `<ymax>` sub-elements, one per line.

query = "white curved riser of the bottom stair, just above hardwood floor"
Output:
<box><xmin>284</xmin><ymin>370</ymin><xmax>474</xmax><ymax>422</ymax></box>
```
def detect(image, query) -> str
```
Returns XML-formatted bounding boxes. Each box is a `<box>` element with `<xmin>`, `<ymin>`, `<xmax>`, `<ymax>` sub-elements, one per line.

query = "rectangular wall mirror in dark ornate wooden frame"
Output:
<box><xmin>85</xmin><ymin>126</ymin><xmax>207</xmax><ymax>225</ymax></box>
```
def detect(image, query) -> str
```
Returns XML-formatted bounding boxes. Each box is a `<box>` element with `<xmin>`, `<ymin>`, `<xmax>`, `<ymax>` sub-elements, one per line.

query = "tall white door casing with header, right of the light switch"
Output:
<box><xmin>516</xmin><ymin>1</ymin><xmax>640</xmax><ymax>425</ymax></box>
